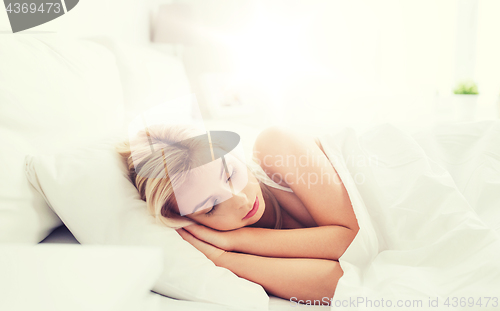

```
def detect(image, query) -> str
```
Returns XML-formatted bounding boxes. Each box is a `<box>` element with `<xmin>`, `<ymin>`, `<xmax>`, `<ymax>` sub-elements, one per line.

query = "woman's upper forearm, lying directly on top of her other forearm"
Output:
<box><xmin>233</xmin><ymin>226</ymin><xmax>357</xmax><ymax>260</ymax></box>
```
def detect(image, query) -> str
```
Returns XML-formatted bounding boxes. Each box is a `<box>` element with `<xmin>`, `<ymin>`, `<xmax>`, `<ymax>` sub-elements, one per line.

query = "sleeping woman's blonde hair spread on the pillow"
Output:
<box><xmin>115</xmin><ymin>125</ymin><xmax>282</xmax><ymax>229</ymax></box>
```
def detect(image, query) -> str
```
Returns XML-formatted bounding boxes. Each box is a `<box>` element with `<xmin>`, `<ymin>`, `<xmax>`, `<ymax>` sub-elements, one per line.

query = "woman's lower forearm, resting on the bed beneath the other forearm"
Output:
<box><xmin>214</xmin><ymin>252</ymin><xmax>343</xmax><ymax>300</ymax></box>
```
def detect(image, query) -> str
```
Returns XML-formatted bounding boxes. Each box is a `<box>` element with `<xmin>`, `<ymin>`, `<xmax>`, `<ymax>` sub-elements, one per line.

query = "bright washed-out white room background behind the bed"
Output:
<box><xmin>0</xmin><ymin>0</ymin><xmax>500</xmax><ymax>131</ymax></box>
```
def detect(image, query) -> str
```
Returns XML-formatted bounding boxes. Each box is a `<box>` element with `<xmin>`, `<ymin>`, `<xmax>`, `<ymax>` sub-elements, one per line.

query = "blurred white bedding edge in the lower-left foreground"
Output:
<box><xmin>0</xmin><ymin>244</ymin><xmax>162</xmax><ymax>311</ymax></box>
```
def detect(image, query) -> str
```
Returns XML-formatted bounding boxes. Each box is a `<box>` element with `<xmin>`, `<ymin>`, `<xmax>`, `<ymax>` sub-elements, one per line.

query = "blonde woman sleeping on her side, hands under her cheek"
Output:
<box><xmin>118</xmin><ymin>126</ymin><xmax>359</xmax><ymax>301</ymax></box>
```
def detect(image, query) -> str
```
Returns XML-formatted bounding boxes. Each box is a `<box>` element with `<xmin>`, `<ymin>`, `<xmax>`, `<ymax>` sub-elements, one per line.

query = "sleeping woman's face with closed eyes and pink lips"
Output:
<box><xmin>175</xmin><ymin>149</ymin><xmax>265</xmax><ymax>231</ymax></box>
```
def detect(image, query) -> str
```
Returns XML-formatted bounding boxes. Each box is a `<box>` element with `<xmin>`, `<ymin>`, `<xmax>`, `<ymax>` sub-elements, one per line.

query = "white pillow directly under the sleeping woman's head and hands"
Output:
<box><xmin>26</xmin><ymin>137</ymin><xmax>269</xmax><ymax>309</ymax></box>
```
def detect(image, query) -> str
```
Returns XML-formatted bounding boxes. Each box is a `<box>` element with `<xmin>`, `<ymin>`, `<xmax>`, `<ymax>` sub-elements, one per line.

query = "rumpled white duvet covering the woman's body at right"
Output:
<box><xmin>320</xmin><ymin>121</ymin><xmax>500</xmax><ymax>310</ymax></box>
